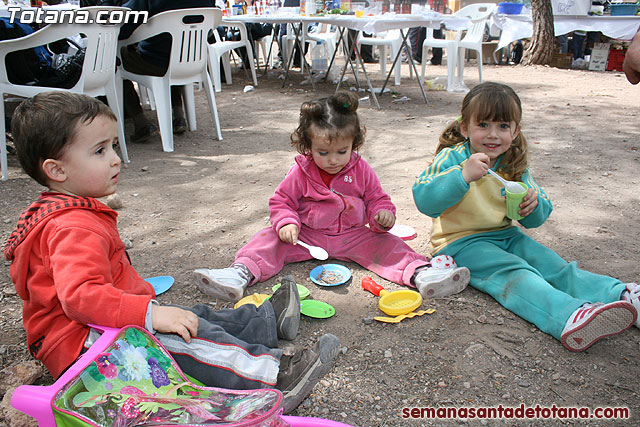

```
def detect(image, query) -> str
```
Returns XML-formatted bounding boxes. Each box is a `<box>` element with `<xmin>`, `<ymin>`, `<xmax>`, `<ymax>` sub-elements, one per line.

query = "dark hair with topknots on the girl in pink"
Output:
<box><xmin>291</xmin><ymin>91</ymin><xmax>365</xmax><ymax>155</ymax></box>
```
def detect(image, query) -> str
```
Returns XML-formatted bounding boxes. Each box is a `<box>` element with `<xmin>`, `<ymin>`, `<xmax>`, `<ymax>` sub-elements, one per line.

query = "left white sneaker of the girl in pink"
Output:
<box><xmin>193</xmin><ymin>267</ymin><xmax>249</xmax><ymax>302</ymax></box>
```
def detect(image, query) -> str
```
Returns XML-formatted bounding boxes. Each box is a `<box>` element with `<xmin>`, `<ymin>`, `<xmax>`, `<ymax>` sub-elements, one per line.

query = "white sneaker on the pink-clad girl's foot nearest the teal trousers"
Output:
<box><xmin>413</xmin><ymin>267</ymin><xmax>471</xmax><ymax>298</ymax></box>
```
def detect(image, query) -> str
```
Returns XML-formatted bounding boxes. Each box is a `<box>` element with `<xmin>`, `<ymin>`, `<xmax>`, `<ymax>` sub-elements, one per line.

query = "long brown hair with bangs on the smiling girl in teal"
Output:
<box><xmin>436</xmin><ymin>82</ymin><xmax>528</xmax><ymax>180</ymax></box>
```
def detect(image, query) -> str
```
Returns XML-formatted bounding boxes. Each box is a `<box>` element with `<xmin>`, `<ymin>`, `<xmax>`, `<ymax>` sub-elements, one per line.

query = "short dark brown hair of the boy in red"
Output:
<box><xmin>11</xmin><ymin>91</ymin><xmax>117</xmax><ymax>187</ymax></box>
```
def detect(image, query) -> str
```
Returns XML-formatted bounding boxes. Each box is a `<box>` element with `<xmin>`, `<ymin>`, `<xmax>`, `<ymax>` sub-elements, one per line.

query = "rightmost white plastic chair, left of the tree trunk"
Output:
<box><xmin>420</xmin><ymin>3</ymin><xmax>497</xmax><ymax>89</ymax></box>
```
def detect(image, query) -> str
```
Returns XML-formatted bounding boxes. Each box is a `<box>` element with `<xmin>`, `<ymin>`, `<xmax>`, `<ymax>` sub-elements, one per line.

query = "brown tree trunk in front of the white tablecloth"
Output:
<box><xmin>522</xmin><ymin>0</ymin><xmax>555</xmax><ymax>65</ymax></box>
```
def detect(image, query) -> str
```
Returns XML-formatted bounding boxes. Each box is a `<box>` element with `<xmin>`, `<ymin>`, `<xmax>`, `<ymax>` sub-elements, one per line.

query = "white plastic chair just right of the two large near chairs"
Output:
<box><xmin>209</xmin><ymin>21</ymin><xmax>258</xmax><ymax>92</ymax></box>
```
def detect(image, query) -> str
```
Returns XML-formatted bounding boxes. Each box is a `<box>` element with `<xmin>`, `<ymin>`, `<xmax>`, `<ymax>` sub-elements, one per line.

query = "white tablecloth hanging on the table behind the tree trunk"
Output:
<box><xmin>491</xmin><ymin>14</ymin><xmax>640</xmax><ymax>49</ymax></box>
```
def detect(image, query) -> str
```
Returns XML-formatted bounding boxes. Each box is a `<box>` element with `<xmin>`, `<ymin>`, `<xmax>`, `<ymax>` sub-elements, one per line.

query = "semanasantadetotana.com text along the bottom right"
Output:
<box><xmin>402</xmin><ymin>404</ymin><xmax>630</xmax><ymax>419</ymax></box>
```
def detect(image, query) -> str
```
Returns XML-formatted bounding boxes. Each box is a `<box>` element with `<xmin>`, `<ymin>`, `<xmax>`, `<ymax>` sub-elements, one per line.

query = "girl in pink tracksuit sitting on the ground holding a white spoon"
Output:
<box><xmin>194</xmin><ymin>92</ymin><xmax>469</xmax><ymax>301</ymax></box>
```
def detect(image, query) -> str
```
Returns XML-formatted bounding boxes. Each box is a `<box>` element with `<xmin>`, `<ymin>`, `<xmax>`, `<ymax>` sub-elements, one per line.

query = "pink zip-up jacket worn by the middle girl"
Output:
<box><xmin>269</xmin><ymin>152</ymin><xmax>396</xmax><ymax>235</ymax></box>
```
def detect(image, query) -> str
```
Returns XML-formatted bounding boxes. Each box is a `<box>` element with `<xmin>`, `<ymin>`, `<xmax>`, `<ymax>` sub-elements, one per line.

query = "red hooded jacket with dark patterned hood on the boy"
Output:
<box><xmin>4</xmin><ymin>192</ymin><xmax>155</xmax><ymax>378</ymax></box>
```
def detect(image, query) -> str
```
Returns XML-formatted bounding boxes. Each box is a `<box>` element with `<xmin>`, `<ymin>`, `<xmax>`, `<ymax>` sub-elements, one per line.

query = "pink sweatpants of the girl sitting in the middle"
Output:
<box><xmin>235</xmin><ymin>226</ymin><xmax>428</xmax><ymax>287</ymax></box>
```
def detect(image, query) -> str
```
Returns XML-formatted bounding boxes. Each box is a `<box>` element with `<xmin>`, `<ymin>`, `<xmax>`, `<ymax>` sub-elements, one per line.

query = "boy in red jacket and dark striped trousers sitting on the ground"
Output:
<box><xmin>4</xmin><ymin>92</ymin><xmax>339</xmax><ymax>412</ymax></box>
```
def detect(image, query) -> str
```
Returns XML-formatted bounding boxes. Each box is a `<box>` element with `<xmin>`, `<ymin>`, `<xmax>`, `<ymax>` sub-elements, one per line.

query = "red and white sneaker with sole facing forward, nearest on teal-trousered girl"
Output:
<box><xmin>560</xmin><ymin>301</ymin><xmax>638</xmax><ymax>351</ymax></box>
